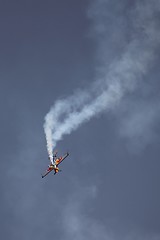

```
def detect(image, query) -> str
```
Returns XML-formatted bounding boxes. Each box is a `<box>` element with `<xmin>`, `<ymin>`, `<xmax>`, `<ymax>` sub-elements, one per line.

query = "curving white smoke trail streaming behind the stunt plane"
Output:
<box><xmin>44</xmin><ymin>0</ymin><xmax>160</xmax><ymax>156</ymax></box>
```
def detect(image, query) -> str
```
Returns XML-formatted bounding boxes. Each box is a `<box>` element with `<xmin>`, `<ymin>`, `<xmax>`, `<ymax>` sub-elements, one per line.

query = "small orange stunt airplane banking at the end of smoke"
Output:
<box><xmin>42</xmin><ymin>151</ymin><xmax>69</xmax><ymax>178</ymax></box>
